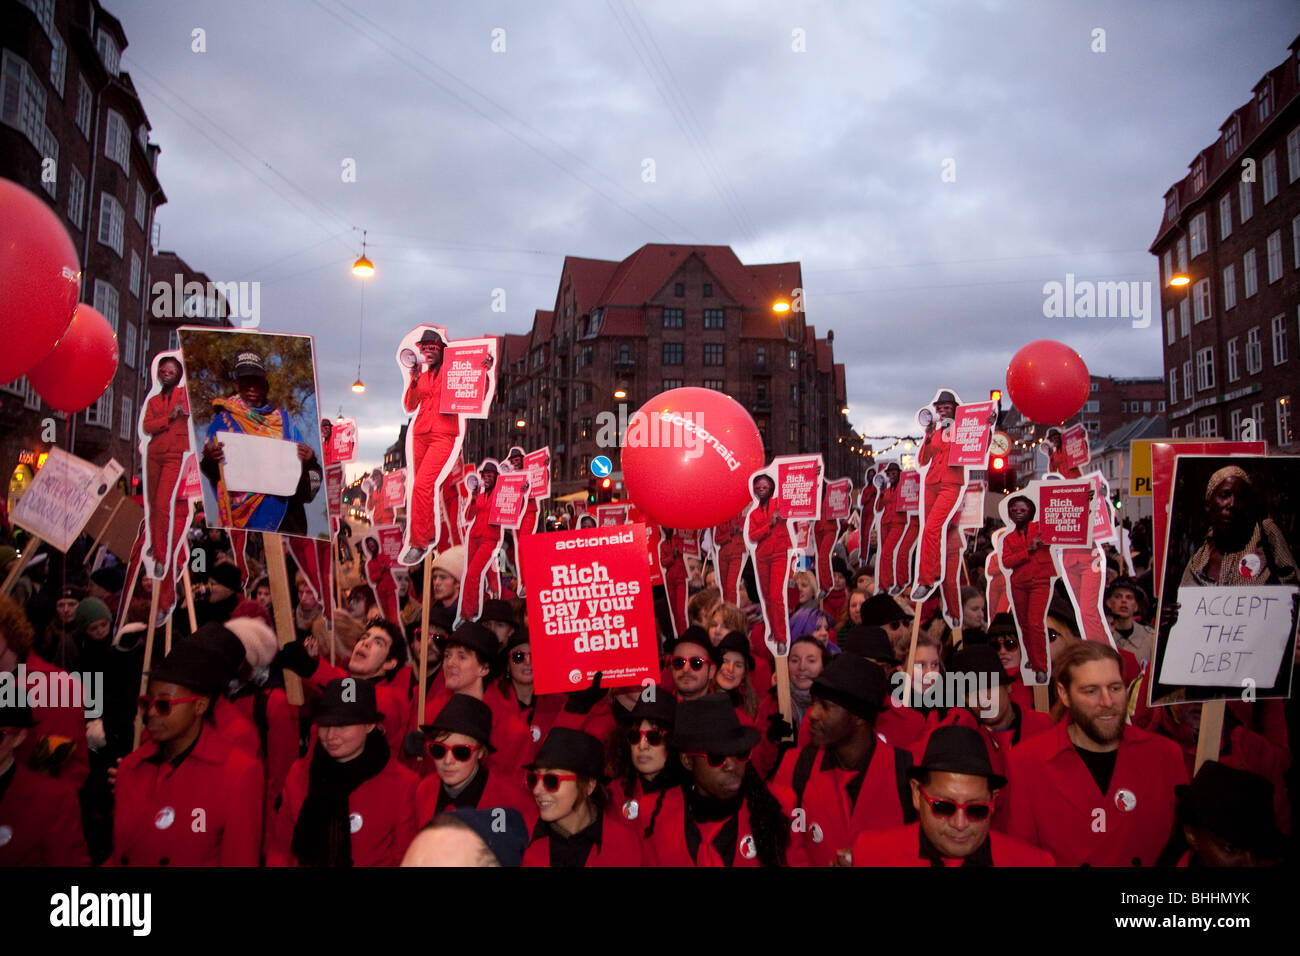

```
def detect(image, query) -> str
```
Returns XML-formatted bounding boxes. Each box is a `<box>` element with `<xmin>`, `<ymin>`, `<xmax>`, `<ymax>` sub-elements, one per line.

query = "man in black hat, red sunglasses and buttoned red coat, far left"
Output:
<box><xmin>108</xmin><ymin>640</ymin><xmax>263</xmax><ymax>866</ymax></box>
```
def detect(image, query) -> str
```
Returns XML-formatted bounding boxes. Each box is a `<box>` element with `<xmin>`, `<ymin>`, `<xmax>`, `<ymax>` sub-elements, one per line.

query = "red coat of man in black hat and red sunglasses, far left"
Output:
<box><xmin>108</xmin><ymin>727</ymin><xmax>263</xmax><ymax>866</ymax></box>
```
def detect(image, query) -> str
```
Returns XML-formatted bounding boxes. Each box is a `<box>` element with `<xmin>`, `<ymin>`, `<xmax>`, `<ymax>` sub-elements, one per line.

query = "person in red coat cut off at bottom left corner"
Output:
<box><xmin>0</xmin><ymin>704</ymin><xmax>90</xmax><ymax>866</ymax></box>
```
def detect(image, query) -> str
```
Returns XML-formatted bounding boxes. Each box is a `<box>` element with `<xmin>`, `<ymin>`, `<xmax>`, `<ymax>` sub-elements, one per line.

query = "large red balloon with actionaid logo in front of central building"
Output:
<box><xmin>623</xmin><ymin>388</ymin><xmax>763</xmax><ymax>529</ymax></box>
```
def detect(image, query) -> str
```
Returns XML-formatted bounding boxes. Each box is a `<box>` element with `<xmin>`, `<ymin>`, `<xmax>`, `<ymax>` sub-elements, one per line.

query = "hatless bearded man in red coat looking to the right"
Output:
<box><xmin>1008</xmin><ymin>641</ymin><xmax>1187</xmax><ymax>866</ymax></box>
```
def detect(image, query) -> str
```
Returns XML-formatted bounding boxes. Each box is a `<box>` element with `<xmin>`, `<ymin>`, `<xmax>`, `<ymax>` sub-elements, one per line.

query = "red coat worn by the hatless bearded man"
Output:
<box><xmin>1008</xmin><ymin>721</ymin><xmax>1187</xmax><ymax>866</ymax></box>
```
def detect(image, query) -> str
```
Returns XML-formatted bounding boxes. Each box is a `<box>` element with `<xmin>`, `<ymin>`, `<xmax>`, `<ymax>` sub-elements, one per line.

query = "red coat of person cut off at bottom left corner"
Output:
<box><xmin>0</xmin><ymin>762</ymin><xmax>90</xmax><ymax>866</ymax></box>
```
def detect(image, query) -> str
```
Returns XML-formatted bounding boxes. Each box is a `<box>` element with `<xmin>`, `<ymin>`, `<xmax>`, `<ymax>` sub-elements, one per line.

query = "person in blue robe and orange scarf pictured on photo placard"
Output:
<box><xmin>199</xmin><ymin>351</ymin><xmax>324</xmax><ymax>535</ymax></box>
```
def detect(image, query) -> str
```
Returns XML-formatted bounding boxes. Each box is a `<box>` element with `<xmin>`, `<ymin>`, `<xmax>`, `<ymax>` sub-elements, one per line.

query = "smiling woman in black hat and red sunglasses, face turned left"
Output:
<box><xmin>524</xmin><ymin>727</ymin><xmax>641</xmax><ymax>866</ymax></box>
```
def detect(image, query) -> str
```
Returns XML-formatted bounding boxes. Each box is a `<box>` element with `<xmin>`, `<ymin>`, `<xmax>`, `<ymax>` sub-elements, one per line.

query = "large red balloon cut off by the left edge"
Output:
<box><xmin>0</xmin><ymin>179</ymin><xmax>81</xmax><ymax>382</ymax></box>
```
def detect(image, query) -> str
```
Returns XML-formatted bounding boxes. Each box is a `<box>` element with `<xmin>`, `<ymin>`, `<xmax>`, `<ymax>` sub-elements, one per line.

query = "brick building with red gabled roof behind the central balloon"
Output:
<box><xmin>464</xmin><ymin>245</ymin><xmax>865</xmax><ymax>496</ymax></box>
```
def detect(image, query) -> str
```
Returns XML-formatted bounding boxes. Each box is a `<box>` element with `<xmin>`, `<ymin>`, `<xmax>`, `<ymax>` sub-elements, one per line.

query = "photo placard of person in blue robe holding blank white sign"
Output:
<box><xmin>177</xmin><ymin>326</ymin><xmax>330</xmax><ymax>541</ymax></box>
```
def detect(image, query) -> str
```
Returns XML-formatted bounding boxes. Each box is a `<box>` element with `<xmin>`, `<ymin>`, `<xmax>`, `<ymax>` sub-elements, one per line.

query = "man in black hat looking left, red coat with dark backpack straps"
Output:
<box><xmin>772</xmin><ymin>653</ymin><xmax>915</xmax><ymax>866</ymax></box>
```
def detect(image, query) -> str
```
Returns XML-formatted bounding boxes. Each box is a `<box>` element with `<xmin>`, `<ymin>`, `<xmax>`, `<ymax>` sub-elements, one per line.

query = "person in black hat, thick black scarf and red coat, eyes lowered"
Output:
<box><xmin>267</xmin><ymin>678</ymin><xmax>420</xmax><ymax>866</ymax></box>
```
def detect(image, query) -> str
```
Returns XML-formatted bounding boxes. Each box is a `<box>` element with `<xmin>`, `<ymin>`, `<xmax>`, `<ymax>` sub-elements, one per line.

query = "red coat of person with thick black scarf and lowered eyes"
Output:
<box><xmin>267</xmin><ymin>754</ymin><xmax>420</xmax><ymax>866</ymax></box>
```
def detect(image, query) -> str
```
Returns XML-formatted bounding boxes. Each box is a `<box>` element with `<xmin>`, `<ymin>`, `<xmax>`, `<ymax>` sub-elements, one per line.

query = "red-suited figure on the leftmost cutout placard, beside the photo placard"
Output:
<box><xmin>140</xmin><ymin>355</ymin><xmax>190</xmax><ymax>578</ymax></box>
